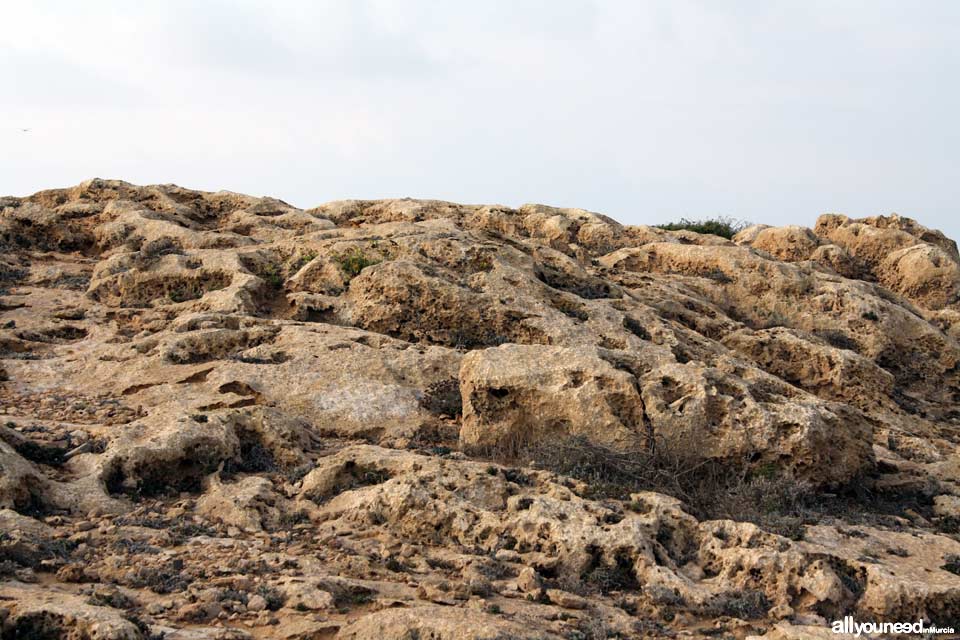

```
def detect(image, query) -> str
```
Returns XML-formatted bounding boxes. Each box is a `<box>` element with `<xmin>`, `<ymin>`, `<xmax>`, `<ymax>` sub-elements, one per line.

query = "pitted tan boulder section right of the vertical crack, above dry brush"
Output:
<box><xmin>640</xmin><ymin>362</ymin><xmax>873</xmax><ymax>485</ymax></box>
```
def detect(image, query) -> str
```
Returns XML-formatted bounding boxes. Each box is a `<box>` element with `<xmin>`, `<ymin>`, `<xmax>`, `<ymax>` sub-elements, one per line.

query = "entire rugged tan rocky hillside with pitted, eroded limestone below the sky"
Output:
<box><xmin>0</xmin><ymin>180</ymin><xmax>960</xmax><ymax>640</ymax></box>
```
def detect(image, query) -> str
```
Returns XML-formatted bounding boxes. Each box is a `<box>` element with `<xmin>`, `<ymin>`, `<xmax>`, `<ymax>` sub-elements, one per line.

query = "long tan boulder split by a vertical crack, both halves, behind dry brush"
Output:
<box><xmin>460</xmin><ymin>345</ymin><xmax>872</xmax><ymax>484</ymax></box>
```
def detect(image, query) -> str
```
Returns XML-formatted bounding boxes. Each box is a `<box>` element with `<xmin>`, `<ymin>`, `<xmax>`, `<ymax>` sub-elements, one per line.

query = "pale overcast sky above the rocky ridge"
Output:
<box><xmin>0</xmin><ymin>0</ymin><xmax>960</xmax><ymax>238</ymax></box>
